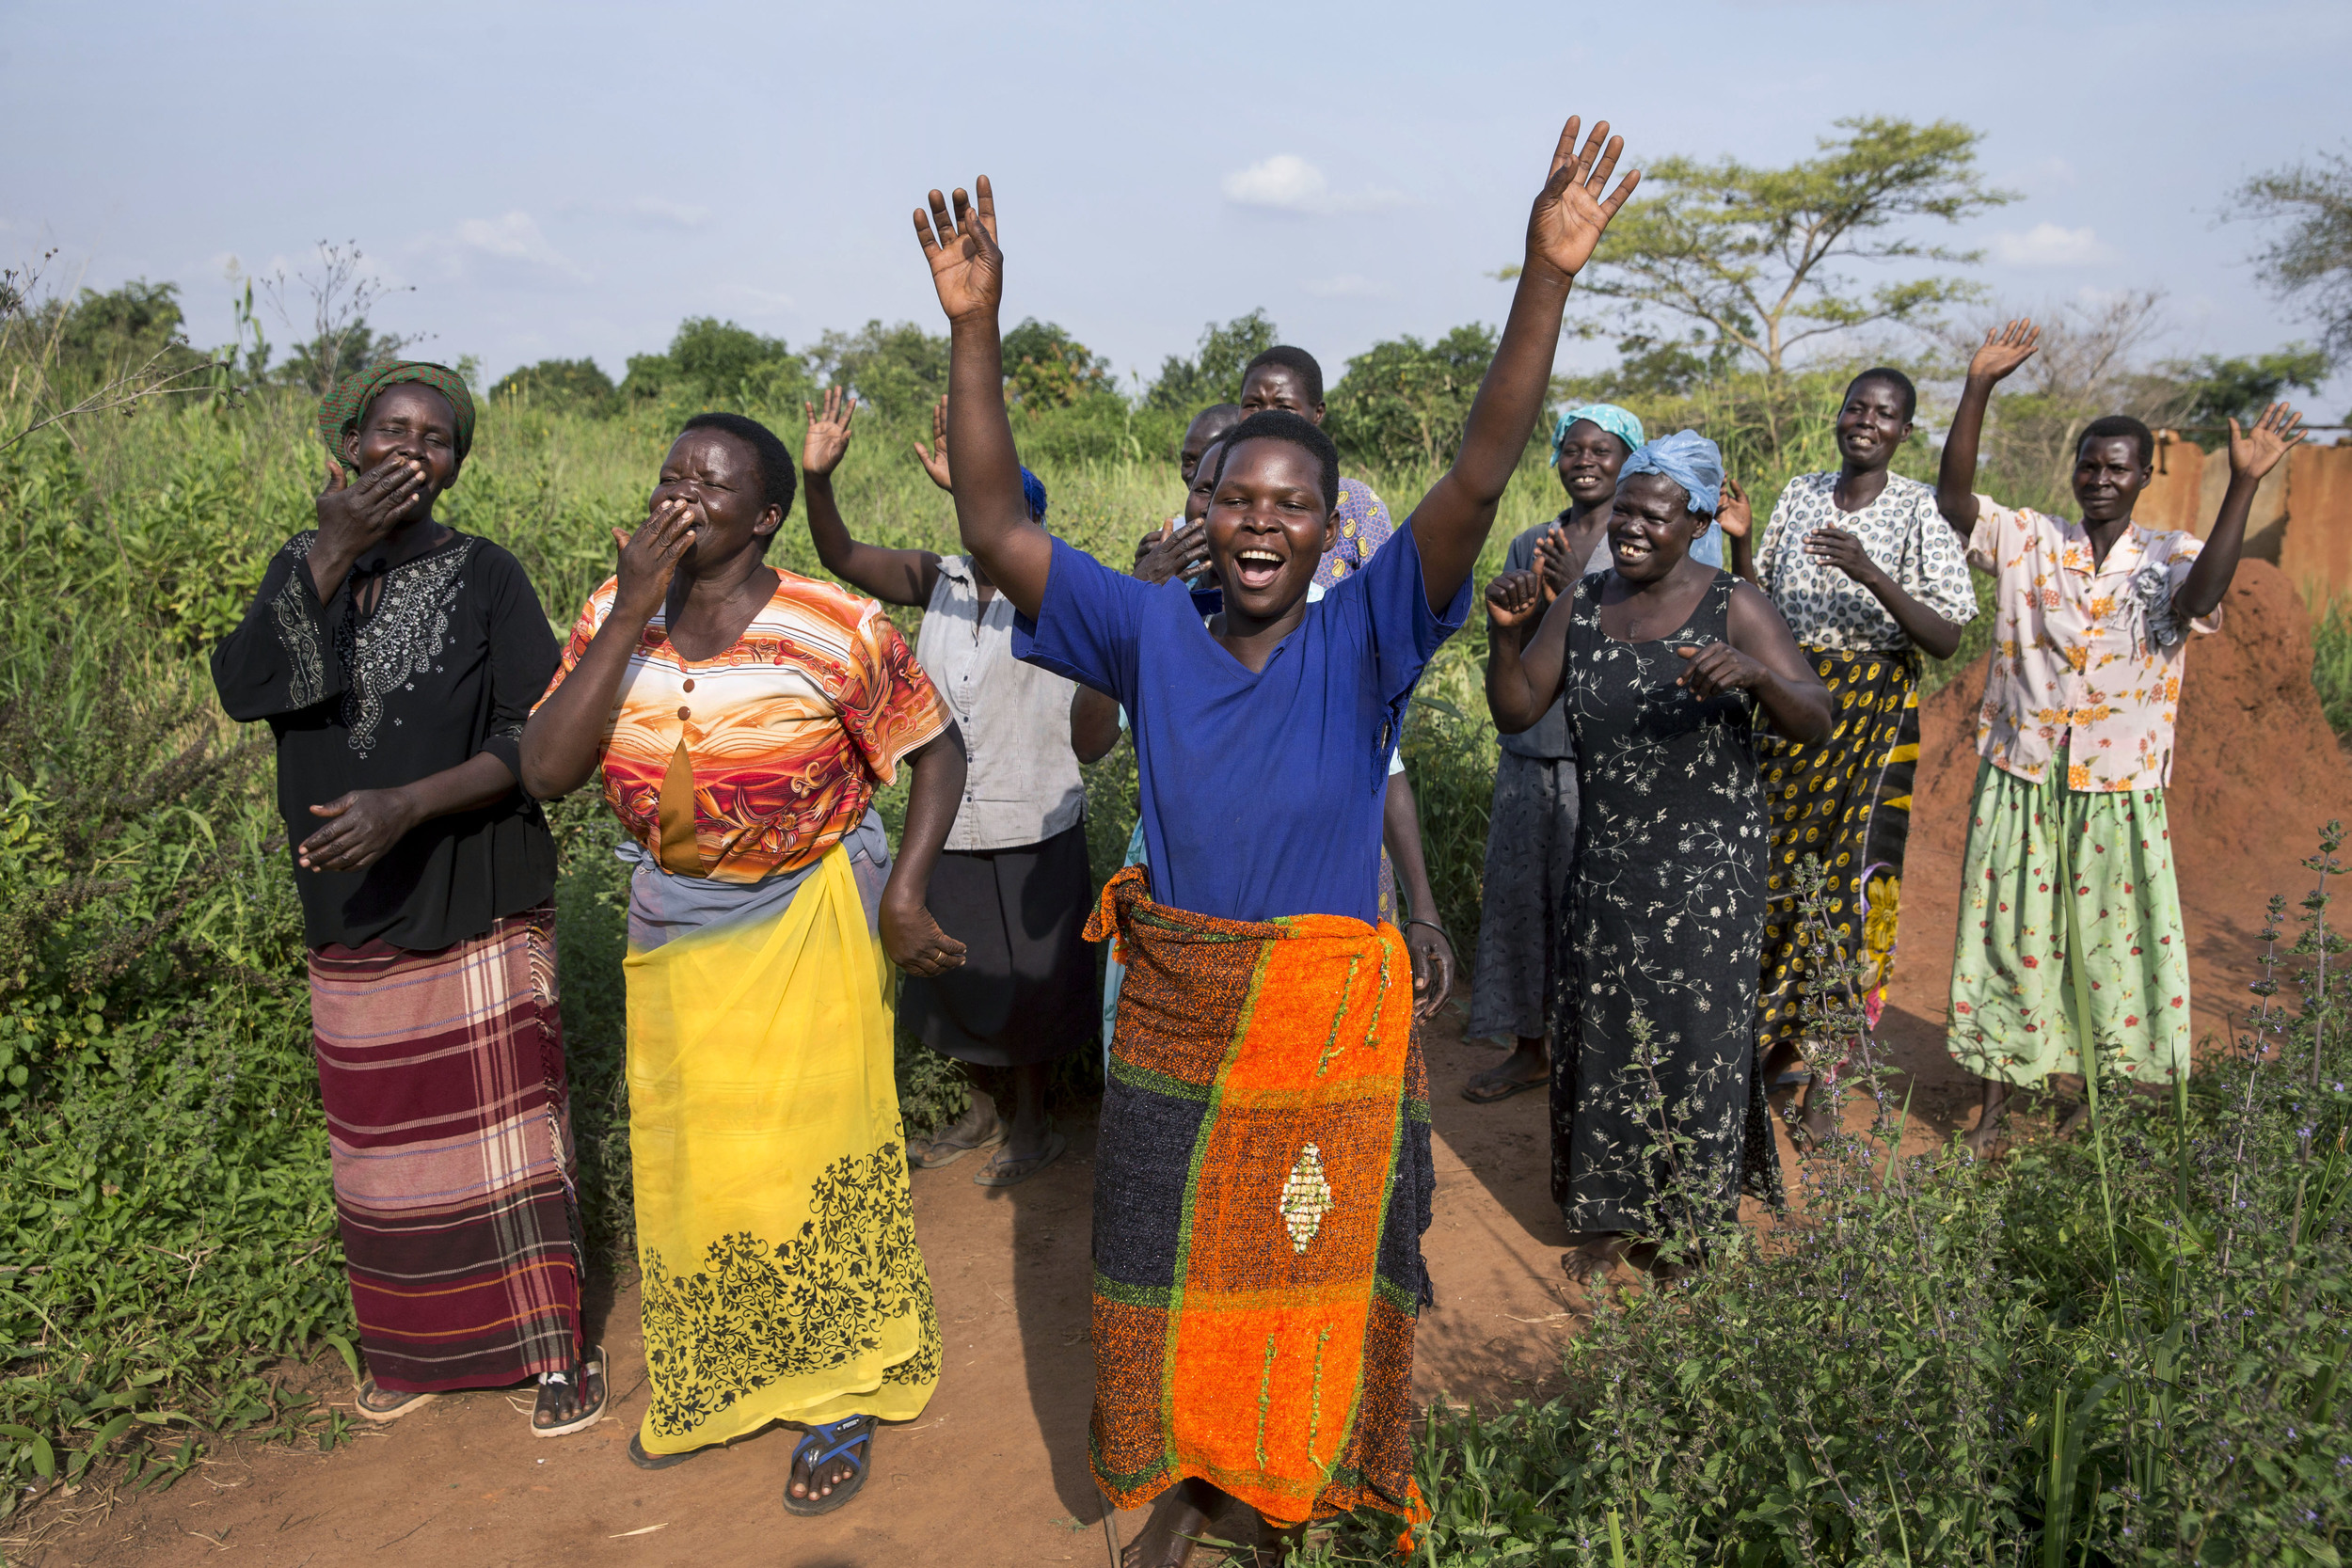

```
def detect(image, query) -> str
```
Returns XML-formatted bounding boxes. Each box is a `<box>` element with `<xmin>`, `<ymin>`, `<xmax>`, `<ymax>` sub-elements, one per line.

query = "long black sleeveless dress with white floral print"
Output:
<box><xmin>1552</xmin><ymin>571</ymin><xmax>1781</xmax><ymax>1237</ymax></box>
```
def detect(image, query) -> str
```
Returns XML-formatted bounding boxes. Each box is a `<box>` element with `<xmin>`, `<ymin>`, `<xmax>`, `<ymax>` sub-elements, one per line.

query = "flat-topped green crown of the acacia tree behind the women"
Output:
<box><xmin>1503</xmin><ymin>115</ymin><xmax>2016</xmax><ymax>376</ymax></box>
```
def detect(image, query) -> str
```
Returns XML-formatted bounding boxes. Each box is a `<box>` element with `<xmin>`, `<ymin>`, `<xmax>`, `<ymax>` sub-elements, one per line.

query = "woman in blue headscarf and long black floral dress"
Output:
<box><xmin>1486</xmin><ymin>430</ymin><xmax>1830</xmax><ymax>1276</ymax></box>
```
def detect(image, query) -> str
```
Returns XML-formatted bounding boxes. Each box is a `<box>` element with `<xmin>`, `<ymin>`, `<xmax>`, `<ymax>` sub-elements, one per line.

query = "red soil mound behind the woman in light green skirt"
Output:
<box><xmin>1894</xmin><ymin>562</ymin><xmax>2352</xmax><ymax>1067</ymax></box>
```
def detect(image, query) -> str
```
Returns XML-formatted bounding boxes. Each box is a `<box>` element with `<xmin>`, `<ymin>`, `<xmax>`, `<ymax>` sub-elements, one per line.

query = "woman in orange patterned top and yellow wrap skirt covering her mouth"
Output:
<box><xmin>522</xmin><ymin>414</ymin><xmax>964</xmax><ymax>1514</ymax></box>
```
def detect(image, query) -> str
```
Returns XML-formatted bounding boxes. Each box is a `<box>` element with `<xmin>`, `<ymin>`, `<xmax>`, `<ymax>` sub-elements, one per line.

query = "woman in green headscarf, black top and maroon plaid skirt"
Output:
<box><xmin>212</xmin><ymin>362</ymin><xmax>605</xmax><ymax>1436</ymax></box>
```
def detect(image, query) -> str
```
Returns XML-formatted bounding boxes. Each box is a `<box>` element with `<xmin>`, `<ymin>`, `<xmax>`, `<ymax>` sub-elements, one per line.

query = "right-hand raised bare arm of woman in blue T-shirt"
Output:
<box><xmin>1406</xmin><ymin>115</ymin><xmax>1642</xmax><ymax>607</ymax></box>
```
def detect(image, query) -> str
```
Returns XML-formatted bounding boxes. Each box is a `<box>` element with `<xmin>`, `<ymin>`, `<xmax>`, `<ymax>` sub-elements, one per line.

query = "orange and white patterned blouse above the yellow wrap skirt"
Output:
<box><xmin>541</xmin><ymin>571</ymin><xmax>948</xmax><ymax>881</ymax></box>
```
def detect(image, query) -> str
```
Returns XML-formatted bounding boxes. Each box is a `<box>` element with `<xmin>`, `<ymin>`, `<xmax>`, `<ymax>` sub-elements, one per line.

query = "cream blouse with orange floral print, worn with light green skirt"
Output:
<box><xmin>1969</xmin><ymin>496</ymin><xmax>2220</xmax><ymax>795</ymax></box>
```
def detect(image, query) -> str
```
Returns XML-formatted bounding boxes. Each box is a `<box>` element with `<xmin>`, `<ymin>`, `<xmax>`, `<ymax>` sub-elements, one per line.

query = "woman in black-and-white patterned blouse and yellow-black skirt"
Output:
<box><xmin>1722</xmin><ymin>367</ymin><xmax>1976</xmax><ymax>1143</ymax></box>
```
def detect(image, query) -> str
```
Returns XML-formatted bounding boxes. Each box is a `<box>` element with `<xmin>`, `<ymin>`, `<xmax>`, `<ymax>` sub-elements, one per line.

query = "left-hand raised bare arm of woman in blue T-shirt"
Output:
<box><xmin>915</xmin><ymin>174</ymin><xmax>1054</xmax><ymax>621</ymax></box>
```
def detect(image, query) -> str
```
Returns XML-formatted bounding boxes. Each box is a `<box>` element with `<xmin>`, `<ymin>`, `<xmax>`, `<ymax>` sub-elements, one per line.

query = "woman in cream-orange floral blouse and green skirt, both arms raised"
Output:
<box><xmin>1936</xmin><ymin>322</ymin><xmax>2303</xmax><ymax>1157</ymax></box>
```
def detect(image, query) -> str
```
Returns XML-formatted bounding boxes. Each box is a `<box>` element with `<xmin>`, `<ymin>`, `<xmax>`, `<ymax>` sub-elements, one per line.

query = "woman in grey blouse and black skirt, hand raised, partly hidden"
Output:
<box><xmin>803</xmin><ymin>388</ymin><xmax>1118</xmax><ymax>1187</ymax></box>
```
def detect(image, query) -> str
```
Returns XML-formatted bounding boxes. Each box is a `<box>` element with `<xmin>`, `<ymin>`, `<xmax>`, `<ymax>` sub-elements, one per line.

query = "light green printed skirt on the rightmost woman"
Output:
<box><xmin>1947</xmin><ymin>750</ymin><xmax>2190</xmax><ymax>1084</ymax></box>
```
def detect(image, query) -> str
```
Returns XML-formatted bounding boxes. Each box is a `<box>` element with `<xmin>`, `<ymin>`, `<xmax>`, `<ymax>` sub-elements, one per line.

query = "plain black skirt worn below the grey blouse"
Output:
<box><xmin>898</xmin><ymin>820</ymin><xmax>1101</xmax><ymax>1068</ymax></box>
